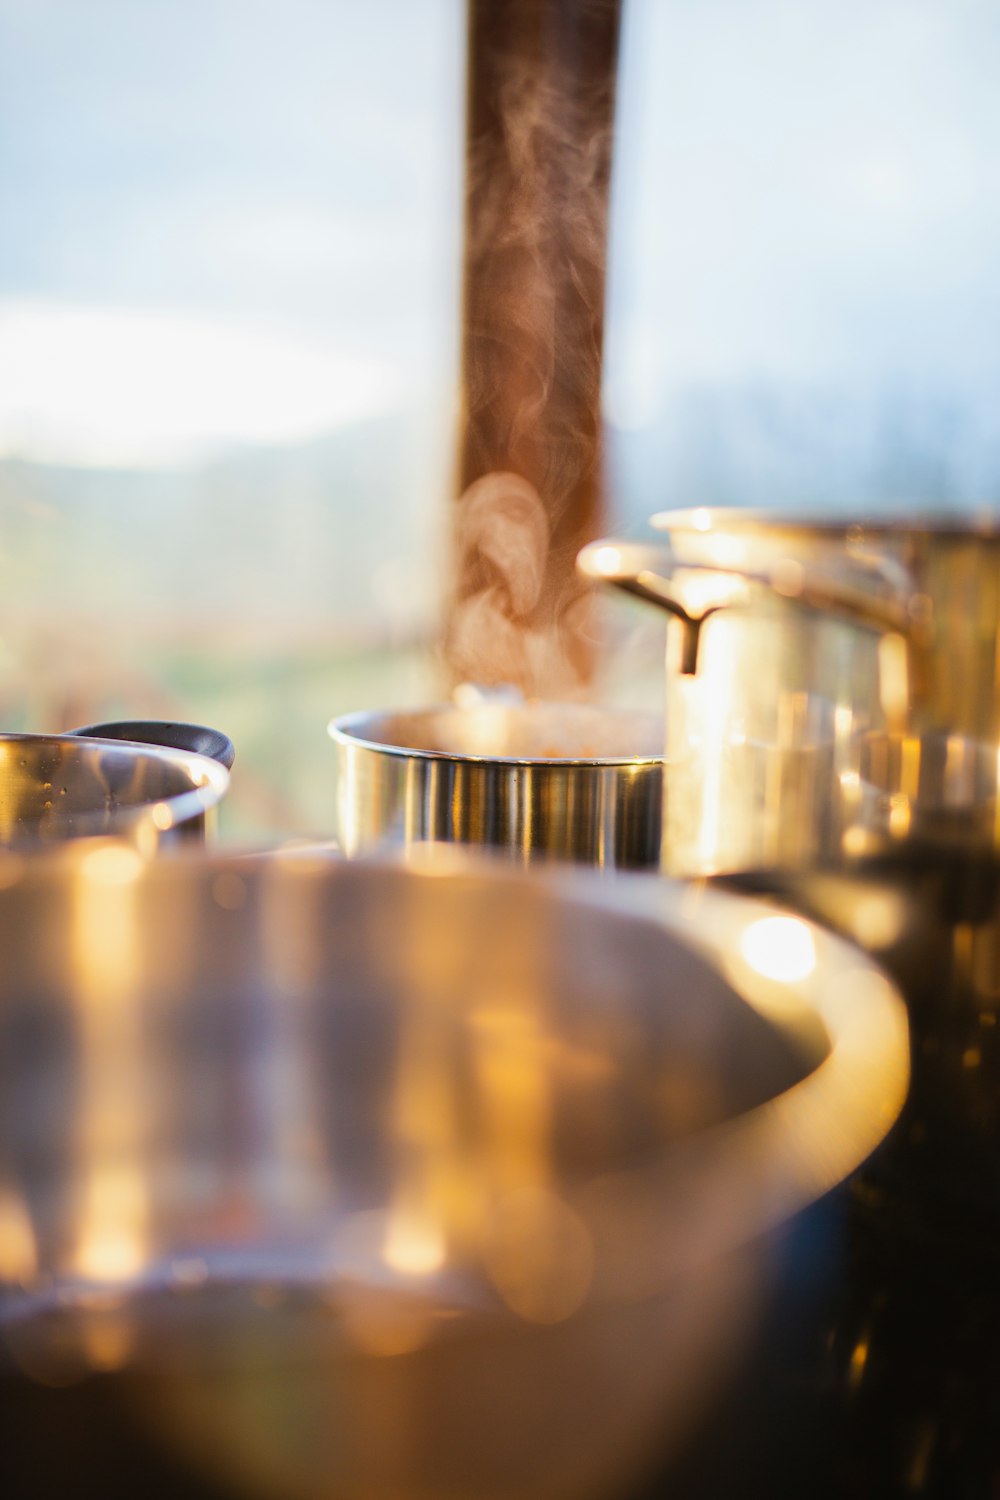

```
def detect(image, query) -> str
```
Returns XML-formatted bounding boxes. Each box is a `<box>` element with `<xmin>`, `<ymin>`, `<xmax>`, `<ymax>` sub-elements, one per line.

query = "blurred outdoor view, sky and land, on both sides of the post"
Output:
<box><xmin>0</xmin><ymin>0</ymin><xmax>1000</xmax><ymax>837</ymax></box>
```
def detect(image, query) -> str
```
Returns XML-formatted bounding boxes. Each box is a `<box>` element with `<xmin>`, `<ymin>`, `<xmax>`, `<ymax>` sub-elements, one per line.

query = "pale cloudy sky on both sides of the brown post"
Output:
<box><xmin>0</xmin><ymin>0</ymin><xmax>1000</xmax><ymax>465</ymax></box>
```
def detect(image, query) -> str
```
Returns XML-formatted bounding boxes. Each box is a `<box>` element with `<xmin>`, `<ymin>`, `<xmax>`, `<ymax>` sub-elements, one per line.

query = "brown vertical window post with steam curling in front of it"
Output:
<box><xmin>445</xmin><ymin>0</ymin><xmax>619</xmax><ymax>698</ymax></box>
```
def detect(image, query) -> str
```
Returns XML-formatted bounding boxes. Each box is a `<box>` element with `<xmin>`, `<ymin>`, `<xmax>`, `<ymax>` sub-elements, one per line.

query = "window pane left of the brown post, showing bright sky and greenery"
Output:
<box><xmin>0</xmin><ymin>0</ymin><xmax>463</xmax><ymax>837</ymax></box>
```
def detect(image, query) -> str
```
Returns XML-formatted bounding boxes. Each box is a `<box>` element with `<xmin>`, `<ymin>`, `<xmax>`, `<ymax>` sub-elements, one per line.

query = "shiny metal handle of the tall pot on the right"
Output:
<box><xmin>577</xmin><ymin>539</ymin><xmax>916</xmax><ymax>674</ymax></box>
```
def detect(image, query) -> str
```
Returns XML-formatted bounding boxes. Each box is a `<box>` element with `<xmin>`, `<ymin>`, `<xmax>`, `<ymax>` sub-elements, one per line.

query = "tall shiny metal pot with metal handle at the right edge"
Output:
<box><xmin>580</xmin><ymin>510</ymin><xmax>1000</xmax><ymax>875</ymax></box>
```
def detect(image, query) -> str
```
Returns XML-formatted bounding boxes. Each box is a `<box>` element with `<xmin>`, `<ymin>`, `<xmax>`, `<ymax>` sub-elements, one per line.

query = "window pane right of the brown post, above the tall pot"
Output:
<box><xmin>606</xmin><ymin>0</ymin><xmax>1000</xmax><ymax>525</ymax></box>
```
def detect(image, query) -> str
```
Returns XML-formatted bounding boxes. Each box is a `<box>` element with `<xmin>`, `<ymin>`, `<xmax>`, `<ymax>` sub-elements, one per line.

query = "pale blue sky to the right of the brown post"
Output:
<box><xmin>609</xmin><ymin>0</ymin><xmax>1000</xmax><ymax>422</ymax></box>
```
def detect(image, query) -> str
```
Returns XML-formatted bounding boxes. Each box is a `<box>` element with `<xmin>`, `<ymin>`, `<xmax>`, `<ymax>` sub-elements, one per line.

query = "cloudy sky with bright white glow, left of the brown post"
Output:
<box><xmin>0</xmin><ymin>0</ymin><xmax>463</xmax><ymax>464</ymax></box>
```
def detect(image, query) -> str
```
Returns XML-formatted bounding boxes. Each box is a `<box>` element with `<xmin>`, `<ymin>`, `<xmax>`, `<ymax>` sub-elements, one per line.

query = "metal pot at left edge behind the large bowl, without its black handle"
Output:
<box><xmin>0</xmin><ymin>734</ymin><xmax>229</xmax><ymax>849</ymax></box>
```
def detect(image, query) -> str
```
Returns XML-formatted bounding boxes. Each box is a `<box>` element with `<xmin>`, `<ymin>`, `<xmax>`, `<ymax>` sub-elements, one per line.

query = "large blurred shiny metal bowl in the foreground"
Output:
<box><xmin>0</xmin><ymin>843</ymin><xmax>907</xmax><ymax>1500</ymax></box>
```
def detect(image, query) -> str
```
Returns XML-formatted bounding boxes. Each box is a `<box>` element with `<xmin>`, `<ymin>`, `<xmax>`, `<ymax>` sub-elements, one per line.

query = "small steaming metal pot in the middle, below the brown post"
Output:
<box><xmin>330</xmin><ymin>702</ymin><xmax>663</xmax><ymax>869</ymax></box>
